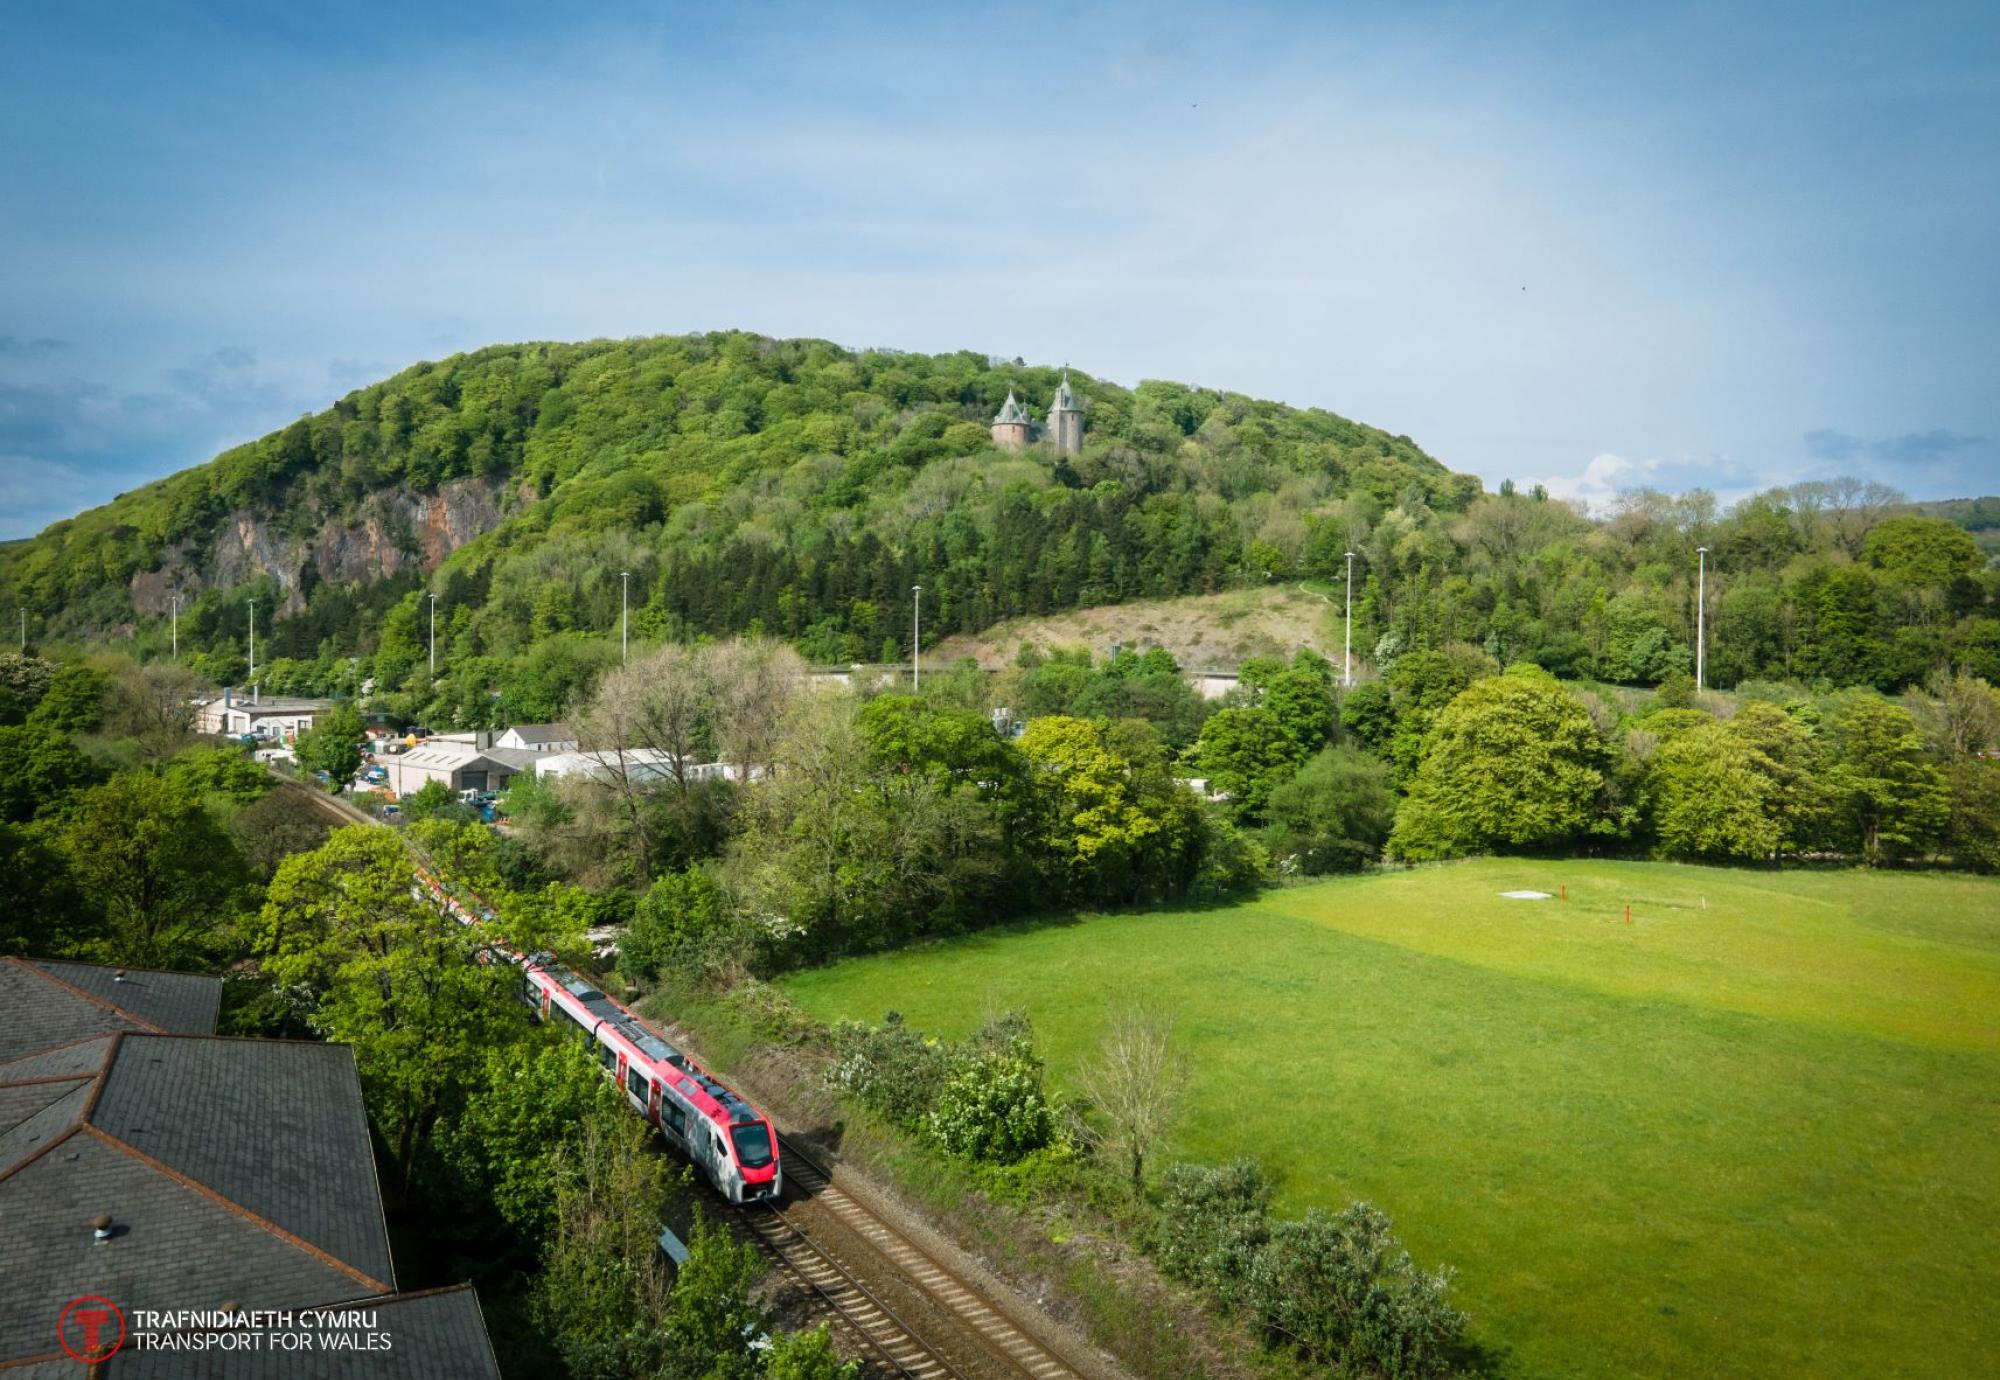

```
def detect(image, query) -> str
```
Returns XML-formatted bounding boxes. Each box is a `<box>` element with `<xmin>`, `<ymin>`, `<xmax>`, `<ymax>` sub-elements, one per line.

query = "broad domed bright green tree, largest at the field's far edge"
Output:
<box><xmin>1388</xmin><ymin>666</ymin><xmax>1610</xmax><ymax>860</ymax></box>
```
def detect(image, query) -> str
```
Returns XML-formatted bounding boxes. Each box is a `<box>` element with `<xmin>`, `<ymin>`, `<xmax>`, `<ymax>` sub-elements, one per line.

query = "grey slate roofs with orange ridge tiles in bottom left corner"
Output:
<box><xmin>0</xmin><ymin>958</ymin><xmax>500</xmax><ymax>1380</ymax></box>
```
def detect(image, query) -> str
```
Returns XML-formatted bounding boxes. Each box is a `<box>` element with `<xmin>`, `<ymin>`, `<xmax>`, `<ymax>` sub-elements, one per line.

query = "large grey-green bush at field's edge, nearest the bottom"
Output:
<box><xmin>1250</xmin><ymin>1202</ymin><xmax>1466</xmax><ymax>1380</ymax></box>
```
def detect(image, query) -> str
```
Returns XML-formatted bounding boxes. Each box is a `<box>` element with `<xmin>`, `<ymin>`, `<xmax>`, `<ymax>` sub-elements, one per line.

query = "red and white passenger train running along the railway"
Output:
<box><xmin>418</xmin><ymin>868</ymin><xmax>784</xmax><ymax>1202</ymax></box>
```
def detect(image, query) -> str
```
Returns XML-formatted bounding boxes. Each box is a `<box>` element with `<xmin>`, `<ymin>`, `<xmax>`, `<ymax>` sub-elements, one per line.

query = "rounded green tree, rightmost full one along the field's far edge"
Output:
<box><xmin>1826</xmin><ymin>690</ymin><xmax>1950</xmax><ymax>864</ymax></box>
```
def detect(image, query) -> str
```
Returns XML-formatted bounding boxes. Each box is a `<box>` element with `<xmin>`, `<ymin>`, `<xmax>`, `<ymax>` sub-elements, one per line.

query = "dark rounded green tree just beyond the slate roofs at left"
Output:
<box><xmin>60</xmin><ymin>772</ymin><xmax>250</xmax><ymax>968</ymax></box>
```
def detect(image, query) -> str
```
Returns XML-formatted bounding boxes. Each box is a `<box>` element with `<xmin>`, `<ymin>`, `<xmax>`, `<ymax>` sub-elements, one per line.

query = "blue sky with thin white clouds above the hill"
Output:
<box><xmin>0</xmin><ymin>0</ymin><xmax>2000</xmax><ymax>536</ymax></box>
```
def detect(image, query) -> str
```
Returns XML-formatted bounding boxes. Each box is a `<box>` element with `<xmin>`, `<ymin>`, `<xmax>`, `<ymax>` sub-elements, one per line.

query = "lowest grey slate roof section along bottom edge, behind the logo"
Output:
<box><xmin>4</xmin><ymin>1284</ymin><xmax>500</xmax><ymax>1380</ymax></box>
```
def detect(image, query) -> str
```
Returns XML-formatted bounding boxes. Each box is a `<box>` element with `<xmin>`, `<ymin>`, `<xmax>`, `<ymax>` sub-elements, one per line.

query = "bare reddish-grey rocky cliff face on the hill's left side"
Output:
<box><xmin>132</xmin><ymin>478</ymin><xmax>506</xmax><ymax>614</ymax></box>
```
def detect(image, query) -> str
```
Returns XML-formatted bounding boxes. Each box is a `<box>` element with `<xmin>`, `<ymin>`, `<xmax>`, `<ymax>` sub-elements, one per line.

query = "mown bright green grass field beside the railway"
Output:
<box><xmin>786</xmin><ymin>860</ymin><xmax>2000</xmax><ymax>1378</ymax></box>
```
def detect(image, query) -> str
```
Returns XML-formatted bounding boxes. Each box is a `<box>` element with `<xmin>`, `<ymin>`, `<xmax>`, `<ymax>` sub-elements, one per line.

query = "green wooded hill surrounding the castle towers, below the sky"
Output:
<box><xmin>0</xmin><ymin>332</ymin><xmax>2000</xmax><ymax>724</ymax></box>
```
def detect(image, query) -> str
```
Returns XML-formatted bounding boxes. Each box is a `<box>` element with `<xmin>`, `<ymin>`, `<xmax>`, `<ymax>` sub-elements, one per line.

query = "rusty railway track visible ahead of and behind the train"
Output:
<box><xmin>272</xmin><ymin>782</ymin><xmax>1084</xmax><ymax>1380</ymax></box>
